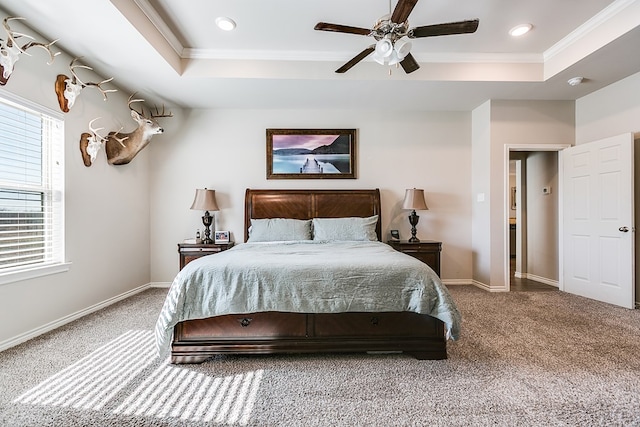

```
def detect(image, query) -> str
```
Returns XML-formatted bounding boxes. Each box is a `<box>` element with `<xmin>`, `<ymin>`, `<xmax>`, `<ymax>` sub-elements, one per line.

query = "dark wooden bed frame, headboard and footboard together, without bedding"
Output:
<box><xmin>171</xmin><ymin>189</ymin><xmax>447</xmax><ymax>363</ymax></box>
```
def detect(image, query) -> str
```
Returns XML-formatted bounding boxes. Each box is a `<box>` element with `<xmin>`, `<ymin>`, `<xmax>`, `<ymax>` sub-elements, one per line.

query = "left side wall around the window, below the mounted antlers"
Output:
<box><xmin>0</xmin><ymin>34</ymin><xmax>151</xmax><ymax>349</ymax></box>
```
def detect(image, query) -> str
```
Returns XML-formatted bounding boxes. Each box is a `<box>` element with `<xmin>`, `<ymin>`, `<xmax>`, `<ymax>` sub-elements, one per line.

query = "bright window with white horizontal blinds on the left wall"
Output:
<box><xmin>0</xmin><ymin>92</ymin><xmax>64</xmax><ymax>283</ymax></box>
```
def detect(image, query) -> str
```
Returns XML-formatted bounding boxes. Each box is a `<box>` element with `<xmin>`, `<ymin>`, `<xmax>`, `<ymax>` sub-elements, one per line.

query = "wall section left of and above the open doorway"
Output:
<box><xmin>472</xmin><ymin>101</ymin><xmax>575</xmax><ymax>291</ymax></box>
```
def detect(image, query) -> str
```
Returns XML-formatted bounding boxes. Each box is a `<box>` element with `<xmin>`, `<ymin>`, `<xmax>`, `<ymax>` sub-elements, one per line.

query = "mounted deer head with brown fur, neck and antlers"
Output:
<box><xmin>105</xmin><ymin>93</ymin><xmax>173</xmax><ymax>165</ymax></box>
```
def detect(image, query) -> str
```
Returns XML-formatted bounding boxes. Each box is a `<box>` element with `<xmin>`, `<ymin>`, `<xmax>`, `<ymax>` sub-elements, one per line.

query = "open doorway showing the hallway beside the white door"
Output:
<box><xmin>504</xmin><ymin>144</ymin><xmax>570</xmax><ymax>292</ymax></box>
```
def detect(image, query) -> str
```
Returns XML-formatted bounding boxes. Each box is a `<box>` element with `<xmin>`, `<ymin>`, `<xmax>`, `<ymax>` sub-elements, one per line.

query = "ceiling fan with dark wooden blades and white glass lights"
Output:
<box><xmin>314</xmin><ymin>0</ymin><xmax>480</xmax><ymax>74</ymax></box>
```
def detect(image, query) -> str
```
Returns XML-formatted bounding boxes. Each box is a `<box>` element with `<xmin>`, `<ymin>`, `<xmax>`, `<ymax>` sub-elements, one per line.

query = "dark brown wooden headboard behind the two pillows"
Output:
<box><xmin>244</xmin><ymin>188</ymin><xmax>382</xmax><ymax>242</ymax></box>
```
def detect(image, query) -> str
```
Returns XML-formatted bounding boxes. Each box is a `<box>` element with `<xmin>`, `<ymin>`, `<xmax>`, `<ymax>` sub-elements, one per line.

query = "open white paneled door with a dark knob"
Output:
<box><xmin>562</xmin><ymin>134</ymin><xmax>635</xmax><ymax>308</ymax></box>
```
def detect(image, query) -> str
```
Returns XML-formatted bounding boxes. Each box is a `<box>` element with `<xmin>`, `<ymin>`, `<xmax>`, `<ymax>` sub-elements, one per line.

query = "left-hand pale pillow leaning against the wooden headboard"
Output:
<box><xmin>247</xmin><ymin>218</ymin><xmax>311</xmax><ymax>243</ymax></box>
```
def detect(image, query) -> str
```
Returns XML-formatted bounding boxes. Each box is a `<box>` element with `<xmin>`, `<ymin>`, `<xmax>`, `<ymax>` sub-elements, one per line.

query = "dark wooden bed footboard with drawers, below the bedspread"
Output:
<box><xmin>171</xmin><ymin>312</ymin><xmax>447</xmax><ymax>363</ymax></box>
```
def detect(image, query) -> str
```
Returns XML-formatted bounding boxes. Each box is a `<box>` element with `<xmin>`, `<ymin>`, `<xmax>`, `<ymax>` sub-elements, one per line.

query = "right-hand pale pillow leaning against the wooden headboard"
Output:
<box><xmin>313</xmin><ymin>215</ymin><xmax>378</xmax><ymax>241</ymax></box>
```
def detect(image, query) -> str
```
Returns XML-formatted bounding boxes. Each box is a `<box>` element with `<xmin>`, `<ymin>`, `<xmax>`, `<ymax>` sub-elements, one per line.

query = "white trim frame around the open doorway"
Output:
<box><xmin>502</xmin><ymin>144</ymin><xmax>573</xmax><ymax>291</ymax></box>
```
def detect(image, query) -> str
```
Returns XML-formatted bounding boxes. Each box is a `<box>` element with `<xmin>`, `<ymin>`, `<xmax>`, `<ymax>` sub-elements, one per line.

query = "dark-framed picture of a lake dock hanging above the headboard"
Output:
<box><xmin>267</xmin><ymin>129</ymin><xmax>356</xmax><ymax>179</ymax></box>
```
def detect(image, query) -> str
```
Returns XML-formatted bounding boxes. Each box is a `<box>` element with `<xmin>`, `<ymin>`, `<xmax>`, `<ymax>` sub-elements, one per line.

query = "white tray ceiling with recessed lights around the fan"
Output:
<box><xmin>0</xmin><ymin>0</ymin><xmax>640</xmax><ymax>111</ymax></box>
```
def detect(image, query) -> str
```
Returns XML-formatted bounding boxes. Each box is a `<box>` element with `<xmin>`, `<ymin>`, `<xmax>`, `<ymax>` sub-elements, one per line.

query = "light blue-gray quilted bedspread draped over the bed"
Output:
<box><xmin>155</xmin><ymin>240</ymin><xmax>460</xmax><ymax>357</ymax></box>
